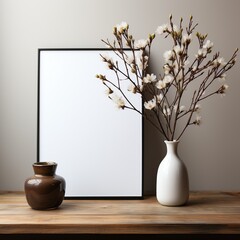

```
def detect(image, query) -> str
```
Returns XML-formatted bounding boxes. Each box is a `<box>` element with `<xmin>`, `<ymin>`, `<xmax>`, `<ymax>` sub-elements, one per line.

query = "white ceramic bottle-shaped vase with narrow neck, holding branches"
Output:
<box><xmin>156</xmin><ymin>141</ymin><xmax>189</xmax><ymax>206</ymax></box>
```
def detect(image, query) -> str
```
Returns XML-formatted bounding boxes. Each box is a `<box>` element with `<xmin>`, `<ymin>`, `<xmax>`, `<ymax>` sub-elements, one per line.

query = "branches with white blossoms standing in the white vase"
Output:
<box><xmin>96</xmin><ymin>16</ymin><xmax>238</xmax><ymax>140</ymax></box>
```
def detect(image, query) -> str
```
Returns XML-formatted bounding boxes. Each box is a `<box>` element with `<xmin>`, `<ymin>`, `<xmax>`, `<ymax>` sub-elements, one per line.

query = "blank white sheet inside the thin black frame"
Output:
<box><xmin>38</xmin><ymin>49</ymin><xmax>142</xmax><ymax>197</ymax></box>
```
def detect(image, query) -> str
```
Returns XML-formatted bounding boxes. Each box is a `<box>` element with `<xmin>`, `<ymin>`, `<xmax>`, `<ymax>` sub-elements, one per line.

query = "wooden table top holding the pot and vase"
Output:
<box><xmin>0</xmin><ymin>192</ymin><xmax>240</xmax><ymax>234</ymax></box>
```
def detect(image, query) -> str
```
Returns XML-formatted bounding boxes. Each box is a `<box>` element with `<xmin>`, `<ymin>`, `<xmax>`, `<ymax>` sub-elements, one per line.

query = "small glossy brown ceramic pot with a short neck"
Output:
<box><xmin>24</xmin><ymin>162</ymin><xmax>66</xmax><ymax>210</ymax></box>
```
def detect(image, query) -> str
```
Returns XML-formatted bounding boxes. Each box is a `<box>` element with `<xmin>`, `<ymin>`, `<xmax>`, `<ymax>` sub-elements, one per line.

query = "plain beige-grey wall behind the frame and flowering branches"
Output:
<box><xmin>0</xmin><ymin>0</ymin><xmax>240</xmax><ymax>193</ymax></box>
